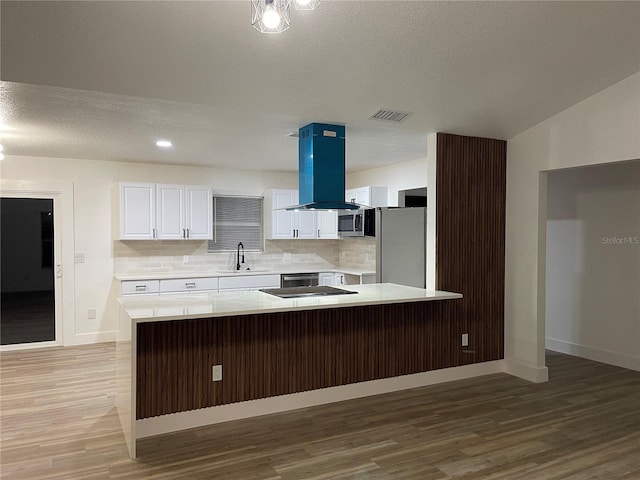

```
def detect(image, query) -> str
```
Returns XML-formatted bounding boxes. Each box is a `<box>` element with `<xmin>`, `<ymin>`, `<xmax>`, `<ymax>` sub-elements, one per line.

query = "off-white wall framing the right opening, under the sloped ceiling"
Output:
<box><xmin>505</xmin><ymin>72</ymin><xmax>640</xmax><ymax>381</ymax></box>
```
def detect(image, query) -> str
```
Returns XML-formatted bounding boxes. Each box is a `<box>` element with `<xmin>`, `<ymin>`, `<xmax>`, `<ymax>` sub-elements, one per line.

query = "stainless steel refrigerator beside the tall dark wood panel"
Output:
<box><xmin>376</xmin><ymin>207</ymin><xmax>427</xmax><ymax>288</ymax></box>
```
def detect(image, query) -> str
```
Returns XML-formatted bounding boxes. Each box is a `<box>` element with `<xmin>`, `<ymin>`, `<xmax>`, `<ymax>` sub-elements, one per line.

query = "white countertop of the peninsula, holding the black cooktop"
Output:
<box><xmin>119</xmin><ymin>284</ymin><xmax>462</xmax><ymax>323</ymax></box>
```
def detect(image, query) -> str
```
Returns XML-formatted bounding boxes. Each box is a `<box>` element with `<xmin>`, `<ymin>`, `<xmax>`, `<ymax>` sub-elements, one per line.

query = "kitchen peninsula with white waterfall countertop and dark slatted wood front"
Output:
<box><xmin>117</xmin><ymin>284</ymin><xmax>462</xmax><ymax>458</ymax></box>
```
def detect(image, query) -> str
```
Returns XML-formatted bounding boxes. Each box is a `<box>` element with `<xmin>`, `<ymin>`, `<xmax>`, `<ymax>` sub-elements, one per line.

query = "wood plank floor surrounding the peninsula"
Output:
<box><xmin>0</xmin><ymin>344</ymin><xmax>640</xmax><ymax>480</ymax></box>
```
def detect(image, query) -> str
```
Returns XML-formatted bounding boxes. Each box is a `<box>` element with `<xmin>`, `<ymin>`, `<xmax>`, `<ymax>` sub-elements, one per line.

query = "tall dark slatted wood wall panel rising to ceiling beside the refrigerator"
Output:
<box><xmin>436</xmin><ymin>133</ymin><xmax>507</xmax><ymax>364</ymax></box>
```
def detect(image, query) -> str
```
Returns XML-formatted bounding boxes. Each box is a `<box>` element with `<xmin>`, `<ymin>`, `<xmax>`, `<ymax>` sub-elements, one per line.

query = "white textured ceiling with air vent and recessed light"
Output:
<box><xmin>0</xmin><ymin>0</ymin><xmax>640</xmax><ymax>171</ymax></box>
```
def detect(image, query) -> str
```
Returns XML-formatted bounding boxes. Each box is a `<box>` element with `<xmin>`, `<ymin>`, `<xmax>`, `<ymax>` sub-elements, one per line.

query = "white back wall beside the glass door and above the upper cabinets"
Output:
<box><xmin>0</xmin><ymin>155</ymin><xmax>297</xmax><ymax>345</ymax></box>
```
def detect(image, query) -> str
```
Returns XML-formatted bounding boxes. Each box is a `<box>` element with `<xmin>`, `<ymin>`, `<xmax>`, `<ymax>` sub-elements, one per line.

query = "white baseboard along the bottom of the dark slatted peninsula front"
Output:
<box><xmin>136</xmin><ymin>360</ymin><xmax>504</xmax><ymax>438</ymax></box>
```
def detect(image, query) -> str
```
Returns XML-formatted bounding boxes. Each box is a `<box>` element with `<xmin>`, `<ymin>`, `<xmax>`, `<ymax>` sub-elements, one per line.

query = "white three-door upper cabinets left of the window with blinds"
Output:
<box><xmin>119</xmin><ymin>183</ymin><xmax>213</xmax><ymax>240</ymax></box>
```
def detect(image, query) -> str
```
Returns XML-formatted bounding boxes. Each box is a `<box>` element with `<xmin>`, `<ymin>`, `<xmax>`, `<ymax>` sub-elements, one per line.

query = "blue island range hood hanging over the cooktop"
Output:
<box><xmin>287</xmin><ymin>123</ymin><xmax>362</xmax><ymax>210</ymax></box>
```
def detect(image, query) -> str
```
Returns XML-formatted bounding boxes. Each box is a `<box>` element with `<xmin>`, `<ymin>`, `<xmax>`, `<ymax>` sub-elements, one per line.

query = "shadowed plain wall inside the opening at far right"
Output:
<box><xmin>546</xmin><ymin>161</ymin><xmax>640</xmax><ymax>370</ymax></box>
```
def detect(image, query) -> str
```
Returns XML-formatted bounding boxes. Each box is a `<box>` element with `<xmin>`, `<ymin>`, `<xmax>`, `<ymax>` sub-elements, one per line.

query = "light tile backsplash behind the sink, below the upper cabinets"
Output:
<box><xmin>113</xmin><ymin>238</ymin><xmax>376</xmax><ymax>274</ymax></box>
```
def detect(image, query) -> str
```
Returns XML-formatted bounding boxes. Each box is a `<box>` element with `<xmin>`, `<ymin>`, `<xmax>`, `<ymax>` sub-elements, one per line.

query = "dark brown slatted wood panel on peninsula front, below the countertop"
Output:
<box><xmin>136</xmin><ymin>299</ymin><xmax>461</xmax><ymax>418</ymax></box>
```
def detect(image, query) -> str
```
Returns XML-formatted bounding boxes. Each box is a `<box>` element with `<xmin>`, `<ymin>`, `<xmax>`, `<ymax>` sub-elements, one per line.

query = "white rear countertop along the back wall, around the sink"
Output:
<box><xmin>114</xmin><ymin>267</ymin><xmax>376</xmax><ymax>281</ymax></box>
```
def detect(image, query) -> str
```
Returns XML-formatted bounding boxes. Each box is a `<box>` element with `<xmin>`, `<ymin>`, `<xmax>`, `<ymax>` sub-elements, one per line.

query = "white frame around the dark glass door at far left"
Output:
<box><xmin>0</xmin><ymin>180</ymin><xmax>75</xmax><ymax>351</ymax></box>
